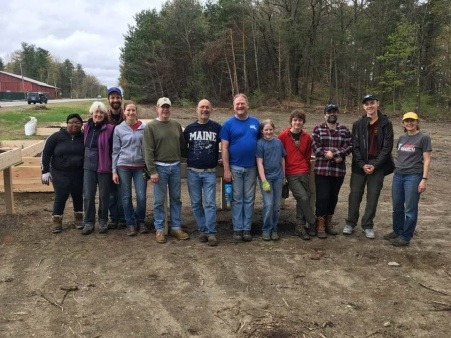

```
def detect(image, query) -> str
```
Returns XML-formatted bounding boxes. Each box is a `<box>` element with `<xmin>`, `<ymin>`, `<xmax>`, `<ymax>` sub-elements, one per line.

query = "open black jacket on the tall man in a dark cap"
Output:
<box><xmin>352</xmin><ymin>111</ymin><xmax>395</xmax><ymax>175</ymax></box>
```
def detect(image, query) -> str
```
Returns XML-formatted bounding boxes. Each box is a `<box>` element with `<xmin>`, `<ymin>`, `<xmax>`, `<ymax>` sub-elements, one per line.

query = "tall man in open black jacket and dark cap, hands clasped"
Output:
<box><xmin>343</xmin><ymin>95</ymin><xmax>395</xmax><ymax>239</ymax></box>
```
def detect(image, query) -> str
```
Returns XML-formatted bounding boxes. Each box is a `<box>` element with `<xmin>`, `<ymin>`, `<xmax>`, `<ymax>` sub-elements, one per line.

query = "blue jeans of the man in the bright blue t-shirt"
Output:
<box><xmin>230</xmin><ymin>166</ymin><xmax>257</xmax><ymax>231</ymax></box>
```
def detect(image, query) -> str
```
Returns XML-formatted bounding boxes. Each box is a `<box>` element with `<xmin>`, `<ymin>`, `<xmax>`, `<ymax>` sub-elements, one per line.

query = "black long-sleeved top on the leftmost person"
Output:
<box><xmin>41</xmin><ymin>128</ymin><xmax>85</xmax><ymax>174</ymax></box>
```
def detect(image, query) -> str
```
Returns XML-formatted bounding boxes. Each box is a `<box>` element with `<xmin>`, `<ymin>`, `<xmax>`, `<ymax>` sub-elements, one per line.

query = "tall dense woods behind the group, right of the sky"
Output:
<box><xmin>120</xmin><ymin>0</ymin><xmax>451</xmax><ymax>112</ymax></box>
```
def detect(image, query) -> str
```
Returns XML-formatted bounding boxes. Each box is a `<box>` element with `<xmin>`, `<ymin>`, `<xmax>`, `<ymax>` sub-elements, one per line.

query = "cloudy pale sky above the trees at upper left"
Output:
<box><xmin>0</xmin><ymin>0</ymin><xmax>167</xmax><ymax>87</ymax></box>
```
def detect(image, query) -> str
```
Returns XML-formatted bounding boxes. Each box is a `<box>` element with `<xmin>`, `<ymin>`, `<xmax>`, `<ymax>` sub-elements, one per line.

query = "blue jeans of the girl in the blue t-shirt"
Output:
<box><xmin>259</xmin><ymin>178</ymin><xmax>283</xmax><ymax>233</ymax></box>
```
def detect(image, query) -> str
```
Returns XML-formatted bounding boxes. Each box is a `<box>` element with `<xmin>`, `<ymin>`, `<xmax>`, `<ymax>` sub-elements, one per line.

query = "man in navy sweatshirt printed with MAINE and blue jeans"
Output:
<box><xmin>183</xmin><ymin>99</ymin><xmax>221</xmax><ymax>246</ymax></box>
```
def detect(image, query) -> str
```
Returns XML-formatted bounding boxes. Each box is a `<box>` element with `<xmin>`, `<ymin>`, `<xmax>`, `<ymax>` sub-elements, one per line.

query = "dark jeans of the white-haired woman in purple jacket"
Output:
<box><xmin>83</xmin><ymin>170</ymin><xmax>112</xmax><ymax>225</ymax></box>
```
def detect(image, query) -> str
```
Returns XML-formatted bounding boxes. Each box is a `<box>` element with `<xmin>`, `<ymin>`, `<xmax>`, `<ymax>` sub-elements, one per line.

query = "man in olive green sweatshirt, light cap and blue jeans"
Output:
<box><xmin>143</xmin><ymin>97</ymin><xmax>189</xmax><ymax>243</ymax></box>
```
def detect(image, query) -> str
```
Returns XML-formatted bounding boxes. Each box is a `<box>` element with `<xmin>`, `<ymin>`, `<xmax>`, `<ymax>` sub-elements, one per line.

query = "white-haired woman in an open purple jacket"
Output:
<box><xmin>82</xmin><ymin>101</ymin><xmax>114</xmax><ymax>235</ymax></box>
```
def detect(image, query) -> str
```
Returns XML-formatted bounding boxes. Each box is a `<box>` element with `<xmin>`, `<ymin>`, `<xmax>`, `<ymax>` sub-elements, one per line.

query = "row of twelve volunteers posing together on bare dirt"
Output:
<box><xmin>42</xmin><ymin>88</ymin><xmax>432</xmax><ymax>246</ymax></box>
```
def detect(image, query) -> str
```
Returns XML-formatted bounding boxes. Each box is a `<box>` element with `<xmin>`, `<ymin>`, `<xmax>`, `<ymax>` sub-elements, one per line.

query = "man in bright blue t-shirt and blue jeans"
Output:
<box><xmin>221</xmin><ymin>94</ymin><xmax>260</xmax><ymax>242</ymax></box>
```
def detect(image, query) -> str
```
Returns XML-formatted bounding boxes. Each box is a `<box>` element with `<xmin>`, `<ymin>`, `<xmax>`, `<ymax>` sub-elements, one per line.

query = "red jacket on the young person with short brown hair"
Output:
<box><xmin>279</xmin><ymin>128</ymin><xmax>312</xmax><ymax>176</ymax></box>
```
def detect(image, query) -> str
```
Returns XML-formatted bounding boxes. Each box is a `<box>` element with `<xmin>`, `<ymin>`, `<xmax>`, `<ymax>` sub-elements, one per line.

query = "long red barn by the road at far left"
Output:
<box><xmin>0</xmin><ymin>71</ymin><xmax>58</xmax><ymax>100</ymax></box>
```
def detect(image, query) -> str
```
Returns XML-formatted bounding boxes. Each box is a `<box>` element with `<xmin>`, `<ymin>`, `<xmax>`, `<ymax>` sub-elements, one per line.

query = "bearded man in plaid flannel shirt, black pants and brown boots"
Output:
<box><xmin>312</xmin><ymin>104</ymin><xmax>352</xmax><ymax>238</ymax></box>
